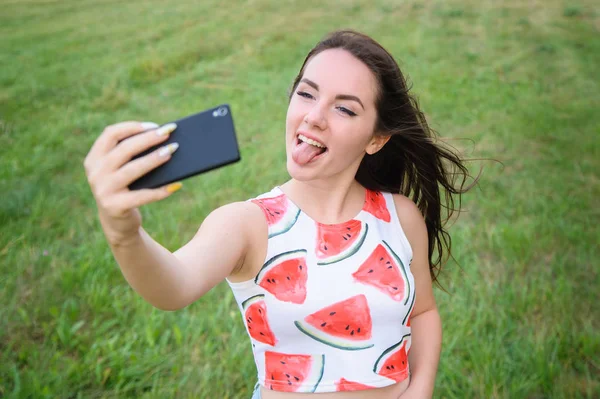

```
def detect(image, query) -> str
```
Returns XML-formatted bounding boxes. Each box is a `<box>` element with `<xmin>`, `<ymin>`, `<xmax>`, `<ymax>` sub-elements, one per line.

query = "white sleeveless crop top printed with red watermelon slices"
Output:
<box><xmin>227</xmin><ymin>187</ymin><xmax>415</xmax><ymax>392</ymax></box>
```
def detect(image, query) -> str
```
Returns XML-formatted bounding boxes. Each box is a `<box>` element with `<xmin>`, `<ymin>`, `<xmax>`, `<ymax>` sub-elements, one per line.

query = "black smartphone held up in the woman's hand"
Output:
<box><xmin>129</xmin><ymin>104</ymin><xmax>240</xmax><ymax>190</ymax></box>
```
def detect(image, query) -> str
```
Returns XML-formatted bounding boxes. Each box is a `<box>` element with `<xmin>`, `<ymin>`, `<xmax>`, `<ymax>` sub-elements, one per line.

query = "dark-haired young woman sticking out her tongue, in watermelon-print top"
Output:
<box><xmin>84</xmin><ymin>31</ymin><xmax>467</xmax><ymax>399</ymax></box>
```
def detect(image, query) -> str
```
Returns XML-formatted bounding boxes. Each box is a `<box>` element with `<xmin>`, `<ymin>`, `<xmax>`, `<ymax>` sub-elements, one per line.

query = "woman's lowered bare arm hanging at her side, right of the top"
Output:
<box><xmin>395</xmin><ymin>195</ymin><xmax>442</xmax><ymax>399</ymax></box>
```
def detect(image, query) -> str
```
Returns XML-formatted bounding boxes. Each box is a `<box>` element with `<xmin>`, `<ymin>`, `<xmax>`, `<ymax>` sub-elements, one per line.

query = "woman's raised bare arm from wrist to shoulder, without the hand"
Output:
<box><xmin>111</xmin><ymin>202</ymin><xmax>262</xmax><ymax>310</ymax></box>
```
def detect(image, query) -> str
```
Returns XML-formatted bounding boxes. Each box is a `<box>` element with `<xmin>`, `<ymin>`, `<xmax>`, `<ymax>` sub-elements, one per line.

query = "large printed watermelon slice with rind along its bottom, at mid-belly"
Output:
<box><xmin>294</xmin><ymin>294</ymin><xmax>373</xmax><ymax>350</ymax></box>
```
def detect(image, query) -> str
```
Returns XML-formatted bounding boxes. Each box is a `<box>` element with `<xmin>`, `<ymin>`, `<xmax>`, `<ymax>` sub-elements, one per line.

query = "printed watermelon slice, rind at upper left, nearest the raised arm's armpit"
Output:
<box><xmin>254</xmin><ymin>249</ymin><xmax>308</xmax><ymax>304</ymax></box>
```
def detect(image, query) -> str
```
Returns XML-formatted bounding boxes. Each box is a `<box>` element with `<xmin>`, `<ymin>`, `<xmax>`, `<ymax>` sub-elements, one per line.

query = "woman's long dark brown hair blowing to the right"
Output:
<box><xmin>290</xmin><ymin>30</ymin><xmax>477</xmax><ymax>283</ymax></box>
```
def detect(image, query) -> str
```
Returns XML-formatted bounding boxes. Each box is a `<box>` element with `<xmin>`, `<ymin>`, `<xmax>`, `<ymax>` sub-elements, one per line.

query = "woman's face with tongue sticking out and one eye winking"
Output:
<box><xmin>286</xmin><ymin>49</ymin><xmax>377</xmax><ymax>181</ymax></box>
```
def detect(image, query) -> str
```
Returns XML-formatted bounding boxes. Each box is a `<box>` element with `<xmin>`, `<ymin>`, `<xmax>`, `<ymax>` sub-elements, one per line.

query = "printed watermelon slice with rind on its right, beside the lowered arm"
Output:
<box><xmin>352</xmin><ymin>241</ymin><xmax>410</xmax><ymax>305</ymax></box>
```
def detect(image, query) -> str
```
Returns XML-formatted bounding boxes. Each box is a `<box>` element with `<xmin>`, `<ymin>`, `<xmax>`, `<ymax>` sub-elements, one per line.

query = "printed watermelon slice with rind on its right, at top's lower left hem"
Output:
<box><xmin>265</xmin><ymin>351</ymin><xmax>325</xmax><ymax>392</ymax></box>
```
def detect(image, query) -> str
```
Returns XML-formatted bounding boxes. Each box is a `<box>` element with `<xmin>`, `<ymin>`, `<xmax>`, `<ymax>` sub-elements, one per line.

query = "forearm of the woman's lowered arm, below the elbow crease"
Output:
<box><xmin>408</xmin><ymin>308</ymin><xmax>442</xmax><ymax>398</ymax></box>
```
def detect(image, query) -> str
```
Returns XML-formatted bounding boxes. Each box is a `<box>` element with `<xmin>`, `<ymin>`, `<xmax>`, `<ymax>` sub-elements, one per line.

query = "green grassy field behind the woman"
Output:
<box><xmin>0</xmin><ymin>0</ymin><xmax>600</xmax><ymax>398</ymax></box>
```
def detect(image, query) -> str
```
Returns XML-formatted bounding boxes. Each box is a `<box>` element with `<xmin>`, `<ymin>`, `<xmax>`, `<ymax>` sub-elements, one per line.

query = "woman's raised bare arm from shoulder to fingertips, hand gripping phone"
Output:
<box><xmin>83</xmin><ymin>121</ymin><xmax>266</xmax><ymax>310</ymax></box>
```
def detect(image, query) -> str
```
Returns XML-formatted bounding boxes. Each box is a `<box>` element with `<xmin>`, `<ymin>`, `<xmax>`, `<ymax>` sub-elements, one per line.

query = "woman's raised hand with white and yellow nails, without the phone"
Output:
<box><xmin>83</xmin><ymin>122</ymin><xmax>181</xmax><ymax>245</ymax></box>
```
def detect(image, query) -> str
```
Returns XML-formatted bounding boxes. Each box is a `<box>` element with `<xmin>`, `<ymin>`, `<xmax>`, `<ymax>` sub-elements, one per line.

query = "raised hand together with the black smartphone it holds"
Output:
<box><xmin>83</xmin><ymin>105</ymin><xmax>240</xmax><ymax>244</ymax></box>
